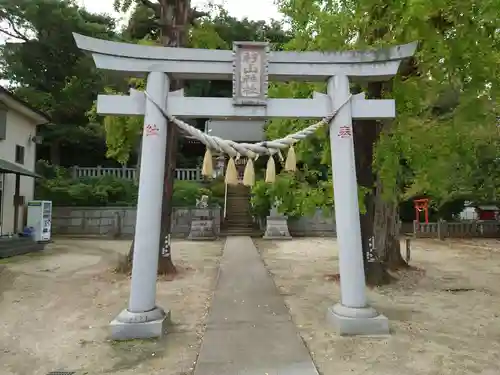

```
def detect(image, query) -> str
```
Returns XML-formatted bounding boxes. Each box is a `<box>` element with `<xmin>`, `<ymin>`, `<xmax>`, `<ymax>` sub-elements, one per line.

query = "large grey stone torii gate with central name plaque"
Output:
<box><xmin>74</xmin><ymin>34</ymin><xmax>417</xmax><ymax>339</ymax></box>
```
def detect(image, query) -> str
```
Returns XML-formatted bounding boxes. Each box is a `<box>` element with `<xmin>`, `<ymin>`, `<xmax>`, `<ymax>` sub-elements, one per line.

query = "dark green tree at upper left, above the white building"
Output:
<box><xmin>0</xmin><ymin>0</ymin><xmax>119</xmax><ymax>162</ymax></box>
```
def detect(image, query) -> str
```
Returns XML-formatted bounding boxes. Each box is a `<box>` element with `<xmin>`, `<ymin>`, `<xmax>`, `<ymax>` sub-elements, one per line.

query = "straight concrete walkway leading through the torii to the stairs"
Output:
<box><xmin>194</xmin><ymin>237</ymin><xmax>318</xmax><ymax>375</ymax></box>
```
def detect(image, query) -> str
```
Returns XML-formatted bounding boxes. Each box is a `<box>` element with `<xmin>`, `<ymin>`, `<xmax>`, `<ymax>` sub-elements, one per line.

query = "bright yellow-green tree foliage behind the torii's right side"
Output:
<box><xmin>267</xmin><ymin>0</ymin><xmax>500</xmax><ymax>206</ymax></box>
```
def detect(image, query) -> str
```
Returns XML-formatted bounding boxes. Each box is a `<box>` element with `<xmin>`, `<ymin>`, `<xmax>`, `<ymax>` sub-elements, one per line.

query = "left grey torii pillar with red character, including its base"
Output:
<box><xmin>110</xmin><ymin>72</ymin><xmax>170</xmax><ymax>340</ymax></box>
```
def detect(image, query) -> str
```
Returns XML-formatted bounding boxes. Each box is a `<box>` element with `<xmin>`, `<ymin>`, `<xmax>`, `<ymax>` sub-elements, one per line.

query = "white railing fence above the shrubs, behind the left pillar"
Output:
<box><xmin>71</xmin><ymin>165</ymin><xmax>203</xmax><ymax>181</ymax></box>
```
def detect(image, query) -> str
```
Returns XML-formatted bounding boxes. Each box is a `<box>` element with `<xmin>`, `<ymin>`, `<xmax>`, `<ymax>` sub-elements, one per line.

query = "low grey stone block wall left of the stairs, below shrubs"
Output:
<box><xmin>52</xmin><ymin>207</ymin><xmax>221</xmax><ymax>237</ymax></box>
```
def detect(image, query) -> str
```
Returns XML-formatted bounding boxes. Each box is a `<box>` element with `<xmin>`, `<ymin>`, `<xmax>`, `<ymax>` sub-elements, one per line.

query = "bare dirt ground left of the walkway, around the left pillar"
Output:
<box><xmin>0</xmin><ymin>239</ymin><xmax>222</xmax><ymax>375</ymax></box>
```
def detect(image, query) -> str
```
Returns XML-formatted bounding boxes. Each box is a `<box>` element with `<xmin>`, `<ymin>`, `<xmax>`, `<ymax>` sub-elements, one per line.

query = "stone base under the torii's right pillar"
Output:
<box><xmin>327</xmin><ymin>303</ymin><xmax>390</xmax><ymax>336</ymax></box>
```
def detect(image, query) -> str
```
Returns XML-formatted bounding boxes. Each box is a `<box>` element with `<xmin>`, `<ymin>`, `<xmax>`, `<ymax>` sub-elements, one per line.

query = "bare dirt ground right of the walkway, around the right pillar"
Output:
<box><xmin>257</xmin><ymin>238</ymin><xmax>500</xmax><ymax>375</ymax></box>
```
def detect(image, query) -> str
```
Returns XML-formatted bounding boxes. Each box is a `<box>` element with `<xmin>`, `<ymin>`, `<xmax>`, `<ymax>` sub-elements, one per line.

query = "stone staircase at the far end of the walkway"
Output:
<box><xmin>221</xmin><ymin>185</ymin><xmax>262</xmax><ymax>237</ymax></box>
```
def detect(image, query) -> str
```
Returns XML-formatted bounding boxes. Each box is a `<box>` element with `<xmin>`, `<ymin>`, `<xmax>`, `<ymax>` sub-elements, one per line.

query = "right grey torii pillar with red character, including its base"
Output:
<box><xmin>327</xmin><ymin>76</ymin><xmax>389</xmax><ymax>335</ymax></box>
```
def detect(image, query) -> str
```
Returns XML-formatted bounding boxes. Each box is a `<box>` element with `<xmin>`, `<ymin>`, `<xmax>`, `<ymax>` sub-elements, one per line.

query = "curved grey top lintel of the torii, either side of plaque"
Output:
<box><xmin>73</xmin><ymin>34</ymin><xmax>418</xmax><ymax>81</ymax></box>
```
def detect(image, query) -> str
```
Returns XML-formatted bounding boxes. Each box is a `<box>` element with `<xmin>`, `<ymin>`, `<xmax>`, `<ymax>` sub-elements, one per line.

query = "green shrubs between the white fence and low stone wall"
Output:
<box><xmin>35</xmin><ymin>162</ymin><xmax>224</xmax><ymax>207</ymax></box>
